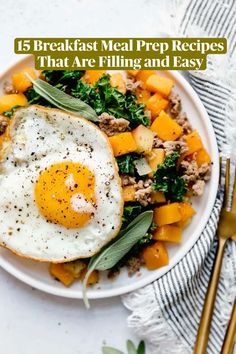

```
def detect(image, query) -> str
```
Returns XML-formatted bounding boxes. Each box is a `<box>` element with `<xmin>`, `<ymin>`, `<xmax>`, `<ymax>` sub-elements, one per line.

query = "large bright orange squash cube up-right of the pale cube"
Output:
<box><xmin>151</xmin><ymin>111</ymin><xmax>183</xmax><ymax>141</ymax></box>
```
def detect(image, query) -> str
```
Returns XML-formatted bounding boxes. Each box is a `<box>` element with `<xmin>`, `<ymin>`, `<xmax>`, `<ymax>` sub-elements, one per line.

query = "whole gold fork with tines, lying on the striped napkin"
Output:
<box><xmin>194</xmin><ymin>158</ymin><xmax>236</xmax><ymax>354</ymax></box>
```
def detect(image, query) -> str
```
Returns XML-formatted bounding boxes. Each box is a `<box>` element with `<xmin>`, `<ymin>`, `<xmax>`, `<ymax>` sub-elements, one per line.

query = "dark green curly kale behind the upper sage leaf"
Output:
<box><xmin>26</xmin><ymin>70</ymin><xmax>150</xmax><ymax>128</ymax></box>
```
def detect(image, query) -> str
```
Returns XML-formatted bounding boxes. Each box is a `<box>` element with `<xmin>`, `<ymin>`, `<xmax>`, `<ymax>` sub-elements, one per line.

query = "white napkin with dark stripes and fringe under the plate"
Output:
<box><xmin>122</xmin><ymin>0</ymin><xmax>236</xmax><ymax>354</ymax></box>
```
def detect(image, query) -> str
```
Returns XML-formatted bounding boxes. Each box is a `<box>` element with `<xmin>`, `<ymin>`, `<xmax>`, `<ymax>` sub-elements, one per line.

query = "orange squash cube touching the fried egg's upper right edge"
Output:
<box><xmin>109</xmin><ymin>132</ymin><xmax>137</xmax><ymax>156</ymax></box>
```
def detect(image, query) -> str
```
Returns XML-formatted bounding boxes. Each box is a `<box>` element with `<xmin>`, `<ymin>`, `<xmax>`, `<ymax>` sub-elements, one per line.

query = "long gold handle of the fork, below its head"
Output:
<box><xmin>193</xmin><ymin>238</ymin><xmax>226</xmax><ymax>354</ymax></box>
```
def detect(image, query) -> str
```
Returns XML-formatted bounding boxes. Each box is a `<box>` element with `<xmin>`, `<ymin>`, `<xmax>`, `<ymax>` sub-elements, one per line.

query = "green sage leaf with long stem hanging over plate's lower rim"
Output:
<box><xmin>83</xmin><ymin>211</ymin><xmax>153</xmax><ymax>308</ymax></box>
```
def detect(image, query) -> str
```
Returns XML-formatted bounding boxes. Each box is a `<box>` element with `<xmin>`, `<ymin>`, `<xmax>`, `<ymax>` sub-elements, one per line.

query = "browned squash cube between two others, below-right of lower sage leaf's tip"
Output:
<box><xmin>153</xmin><ymin>225</ymin><xmax>182</xmax><ymax>243</ymax></box>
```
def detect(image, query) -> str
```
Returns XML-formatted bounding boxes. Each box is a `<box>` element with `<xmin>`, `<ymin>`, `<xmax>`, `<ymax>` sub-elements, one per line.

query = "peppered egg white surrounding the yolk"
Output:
<box><xmin>0</xmin><ymin>106</ymin><xmax>123</xmax><ymax>262</ymax></box>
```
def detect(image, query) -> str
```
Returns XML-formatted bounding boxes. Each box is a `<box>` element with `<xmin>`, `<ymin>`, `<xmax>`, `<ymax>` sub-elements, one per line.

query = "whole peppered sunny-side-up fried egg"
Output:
<box><xmin>0</xmin><ymin>106</ymin><xmax>123</xmax><ymax>262</ymax></box>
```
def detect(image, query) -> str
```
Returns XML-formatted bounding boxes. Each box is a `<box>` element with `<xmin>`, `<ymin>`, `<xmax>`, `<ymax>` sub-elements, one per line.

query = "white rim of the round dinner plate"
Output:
<box><xmin>0</xmin><ymin>55</ymin><xmax>219</xmax><ymax>299</ymax></box>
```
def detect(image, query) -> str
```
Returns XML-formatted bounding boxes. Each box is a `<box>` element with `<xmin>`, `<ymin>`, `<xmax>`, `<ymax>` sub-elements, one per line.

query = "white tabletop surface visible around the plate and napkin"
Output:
<box><xmin>0</xmin><ymin>0</ymin><xmax>168</xmax><ymax>354</ymax></box>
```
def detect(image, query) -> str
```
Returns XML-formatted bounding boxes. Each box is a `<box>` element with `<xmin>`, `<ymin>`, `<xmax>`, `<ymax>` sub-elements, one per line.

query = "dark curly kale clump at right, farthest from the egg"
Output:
<box><xmin>153</xmin><ymin>151</ymin><xmax>187</xmax><ymax>202</ymax></box>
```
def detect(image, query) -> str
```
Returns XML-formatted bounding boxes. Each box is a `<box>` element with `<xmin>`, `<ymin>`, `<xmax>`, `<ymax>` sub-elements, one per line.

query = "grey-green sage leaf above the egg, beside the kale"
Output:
<box><xmin>25</xmin><ymin>73</ymin><xmax>98</xmax><ymax>122</ymax></box>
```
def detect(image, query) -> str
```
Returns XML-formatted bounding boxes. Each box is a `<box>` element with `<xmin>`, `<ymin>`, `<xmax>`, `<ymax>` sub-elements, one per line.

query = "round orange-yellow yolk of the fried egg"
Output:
<box><xmin>35</xmin><ymin>162</ymin><xmax>96</xmax><ymax>228</ymax></box>
